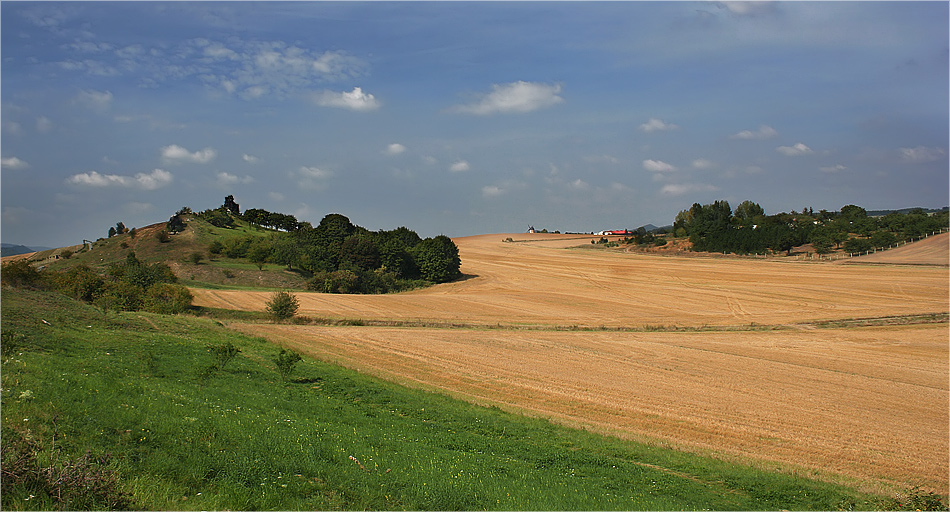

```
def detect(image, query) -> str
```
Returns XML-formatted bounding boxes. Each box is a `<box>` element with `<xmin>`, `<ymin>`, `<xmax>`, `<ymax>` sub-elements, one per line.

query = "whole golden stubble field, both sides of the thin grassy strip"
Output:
<box><xmin>193</xmin><ymin>234</ymin><xmax>950</xmax><ymax>493</ymax></box>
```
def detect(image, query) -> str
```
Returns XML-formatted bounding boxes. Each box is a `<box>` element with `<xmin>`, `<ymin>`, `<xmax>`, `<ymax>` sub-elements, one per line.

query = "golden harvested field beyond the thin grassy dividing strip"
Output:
<box><xmin>193</xmin><ymin>235</ymin><xmax>950</xmax><ymax>327</ymax></box>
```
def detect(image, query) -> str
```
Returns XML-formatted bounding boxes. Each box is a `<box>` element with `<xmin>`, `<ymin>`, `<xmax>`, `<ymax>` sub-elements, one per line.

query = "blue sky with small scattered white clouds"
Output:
<box><xmin>0</xmin><ymin>1</ymin><xmax>950</xmax><ymax>247</ymax></box>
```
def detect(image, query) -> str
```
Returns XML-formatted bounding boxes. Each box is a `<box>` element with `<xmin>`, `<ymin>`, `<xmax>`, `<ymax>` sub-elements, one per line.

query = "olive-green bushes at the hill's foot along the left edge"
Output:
<box><xmin>2</xmin><ymin>252</ymin><xmax>192</xmax><ymax>314</ymax></box>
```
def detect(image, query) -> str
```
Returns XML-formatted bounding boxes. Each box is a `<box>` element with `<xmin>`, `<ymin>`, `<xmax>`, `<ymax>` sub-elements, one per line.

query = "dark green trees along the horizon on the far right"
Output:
<box><xmin>673</xmin><ymin>201</ymin><xmax>950</xmax><ymax>254</ymax></box>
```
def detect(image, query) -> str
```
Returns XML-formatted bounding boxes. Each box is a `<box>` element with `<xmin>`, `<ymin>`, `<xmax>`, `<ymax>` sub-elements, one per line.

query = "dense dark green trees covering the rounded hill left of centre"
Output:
<box><xmin>178</xmin><ymin>198</ymin><xmax>461</xmax><ymax>293</ymax></box>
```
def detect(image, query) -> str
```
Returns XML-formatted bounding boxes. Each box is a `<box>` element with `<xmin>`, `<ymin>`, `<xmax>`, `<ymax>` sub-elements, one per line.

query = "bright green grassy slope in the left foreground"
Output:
<box><xmin>2</xmin><ymin>289</ymin><xmax>892</xmax><ymax>510</ymax></box>
